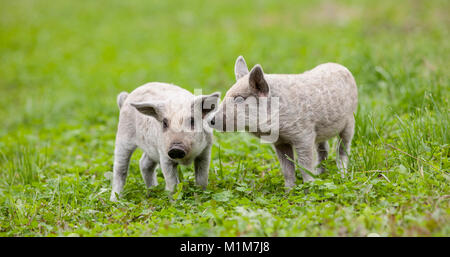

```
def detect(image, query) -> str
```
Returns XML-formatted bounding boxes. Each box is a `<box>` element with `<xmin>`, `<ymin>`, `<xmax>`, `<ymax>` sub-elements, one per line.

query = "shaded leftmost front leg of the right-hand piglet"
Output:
<box><xmin>274</xmin><ymin>144</ymin><xmax>296</xmax><ymax>191</ymax></box>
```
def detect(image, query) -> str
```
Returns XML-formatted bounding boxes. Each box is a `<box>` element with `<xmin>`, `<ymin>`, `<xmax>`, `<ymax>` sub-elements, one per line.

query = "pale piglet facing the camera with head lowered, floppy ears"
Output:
<box><xmin>111</xmin><ymin>82</ymin><xmax>220</xmax><ymax>201</ymax></box>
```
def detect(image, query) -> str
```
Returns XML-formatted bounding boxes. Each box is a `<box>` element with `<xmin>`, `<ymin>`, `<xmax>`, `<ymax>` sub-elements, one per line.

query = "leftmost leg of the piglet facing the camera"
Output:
<box><xmin>110</xmin><ymin>139</ymin><xmax>136</xmax><ymax>202</ymax></box>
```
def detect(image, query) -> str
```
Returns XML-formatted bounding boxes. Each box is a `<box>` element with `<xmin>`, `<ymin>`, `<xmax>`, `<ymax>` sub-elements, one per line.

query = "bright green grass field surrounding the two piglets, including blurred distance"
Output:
<box><xmin>0</xmin><ymin>0</ymin><xmax>450</xmax><ymax>236</ymax></box>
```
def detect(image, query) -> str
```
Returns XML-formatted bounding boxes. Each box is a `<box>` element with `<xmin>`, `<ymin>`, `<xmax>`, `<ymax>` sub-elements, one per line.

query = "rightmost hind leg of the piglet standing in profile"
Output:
<box><xmin>336</xmin><ymin>115</ymin><xmax>355</xmax><ymax>178</ymax></box>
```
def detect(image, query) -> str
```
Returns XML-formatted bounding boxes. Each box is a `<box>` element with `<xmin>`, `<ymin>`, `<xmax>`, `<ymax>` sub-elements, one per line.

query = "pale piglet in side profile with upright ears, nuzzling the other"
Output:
<box><xmin>210</xmin><ymin>56</ymin><xmax>358</xmax><ymax>188</ymax></box>
